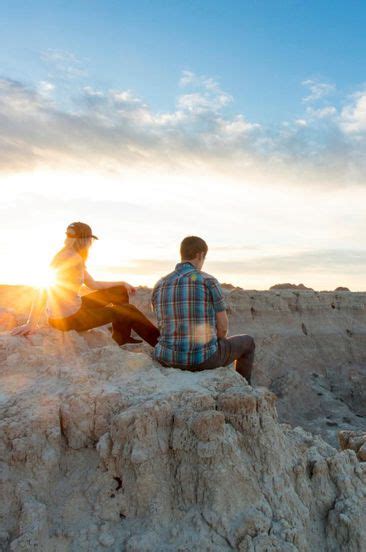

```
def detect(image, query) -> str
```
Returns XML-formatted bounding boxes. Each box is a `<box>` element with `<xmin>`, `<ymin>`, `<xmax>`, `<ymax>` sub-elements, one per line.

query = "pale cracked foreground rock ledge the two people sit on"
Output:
<box><xmin>0</xmin><ymin>330</ymin><xmax>366</xmax><ymax>552</ymax></box>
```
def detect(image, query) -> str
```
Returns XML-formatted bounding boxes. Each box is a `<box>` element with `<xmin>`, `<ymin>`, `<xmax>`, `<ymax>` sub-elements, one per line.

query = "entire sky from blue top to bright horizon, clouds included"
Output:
<box><xmin>0</xmin><ymin>0</ymin><xmax>366</xmax><ymax>291</ymax></box>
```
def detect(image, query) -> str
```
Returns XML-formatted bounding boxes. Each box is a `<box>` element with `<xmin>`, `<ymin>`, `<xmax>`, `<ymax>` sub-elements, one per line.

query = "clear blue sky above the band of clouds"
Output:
<box><xmin>0</xmin><ymin>0</ymin><xmax>366</xmax><ymax>123</ymax></box>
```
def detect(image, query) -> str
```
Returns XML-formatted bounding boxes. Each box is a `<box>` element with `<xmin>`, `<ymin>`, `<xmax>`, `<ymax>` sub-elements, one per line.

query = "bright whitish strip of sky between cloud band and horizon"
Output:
<box><xmin>0</xmin><ymin>167</ymin><xmax>366</xmax><ymax>290</ymax></box>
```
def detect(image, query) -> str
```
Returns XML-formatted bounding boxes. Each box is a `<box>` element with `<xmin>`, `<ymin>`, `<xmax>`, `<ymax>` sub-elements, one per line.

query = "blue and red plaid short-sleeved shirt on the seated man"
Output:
<box><xmin>152</xmin><ymin>262</ymin><xmax>226</xmax><ymax>367</ymax></box>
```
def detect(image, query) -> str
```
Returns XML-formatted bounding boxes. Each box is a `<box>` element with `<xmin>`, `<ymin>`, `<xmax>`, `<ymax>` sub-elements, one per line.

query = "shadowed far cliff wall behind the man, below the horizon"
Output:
<box><xmin>136</xmin><ymin>288</ymin><xmax>366</xmax><ymax>446</ymax></box>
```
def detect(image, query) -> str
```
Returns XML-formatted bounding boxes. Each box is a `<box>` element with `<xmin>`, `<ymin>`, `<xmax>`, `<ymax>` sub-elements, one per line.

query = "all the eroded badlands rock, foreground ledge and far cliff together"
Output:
<box><xmin>0</xmin><ymin>286</ymin><xmax>366</xmax><ymax>552</ymax></box>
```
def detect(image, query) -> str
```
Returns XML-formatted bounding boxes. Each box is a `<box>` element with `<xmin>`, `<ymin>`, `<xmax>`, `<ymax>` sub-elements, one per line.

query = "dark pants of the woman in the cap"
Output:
<box><xmin>49</xmin><ymin>286</ymin><xmax>159</xmax><ymax>347</ymax></box>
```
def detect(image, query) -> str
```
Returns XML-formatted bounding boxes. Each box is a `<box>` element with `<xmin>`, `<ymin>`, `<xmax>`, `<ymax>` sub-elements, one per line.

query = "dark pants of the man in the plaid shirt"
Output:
<box><xmin>161</xmin><ymin>335</ymin><xmax>255</xmax><ymax>384</ymax></box>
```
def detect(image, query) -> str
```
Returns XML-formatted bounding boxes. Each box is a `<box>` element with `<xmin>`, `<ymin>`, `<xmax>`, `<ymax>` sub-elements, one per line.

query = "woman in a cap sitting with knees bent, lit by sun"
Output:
<box><xmin>12</xmin><ymin>222</ymin><xmax>159</xmax><ymax>347</ymax></box>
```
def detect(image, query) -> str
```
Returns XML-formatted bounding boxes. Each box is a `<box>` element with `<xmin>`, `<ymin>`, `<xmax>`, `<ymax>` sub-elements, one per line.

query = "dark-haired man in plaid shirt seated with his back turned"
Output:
<box><xmin>152</xmin><ymin>236</ymin><xmax>255</xmax><ymax>383</ymax></box>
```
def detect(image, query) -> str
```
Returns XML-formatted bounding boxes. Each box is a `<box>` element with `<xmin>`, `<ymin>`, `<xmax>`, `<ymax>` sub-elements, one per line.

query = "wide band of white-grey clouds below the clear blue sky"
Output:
<box><xmin>0</xmin><ymin>71</ymin><xmax>366</xmax><ymax>186</ymax></box>
